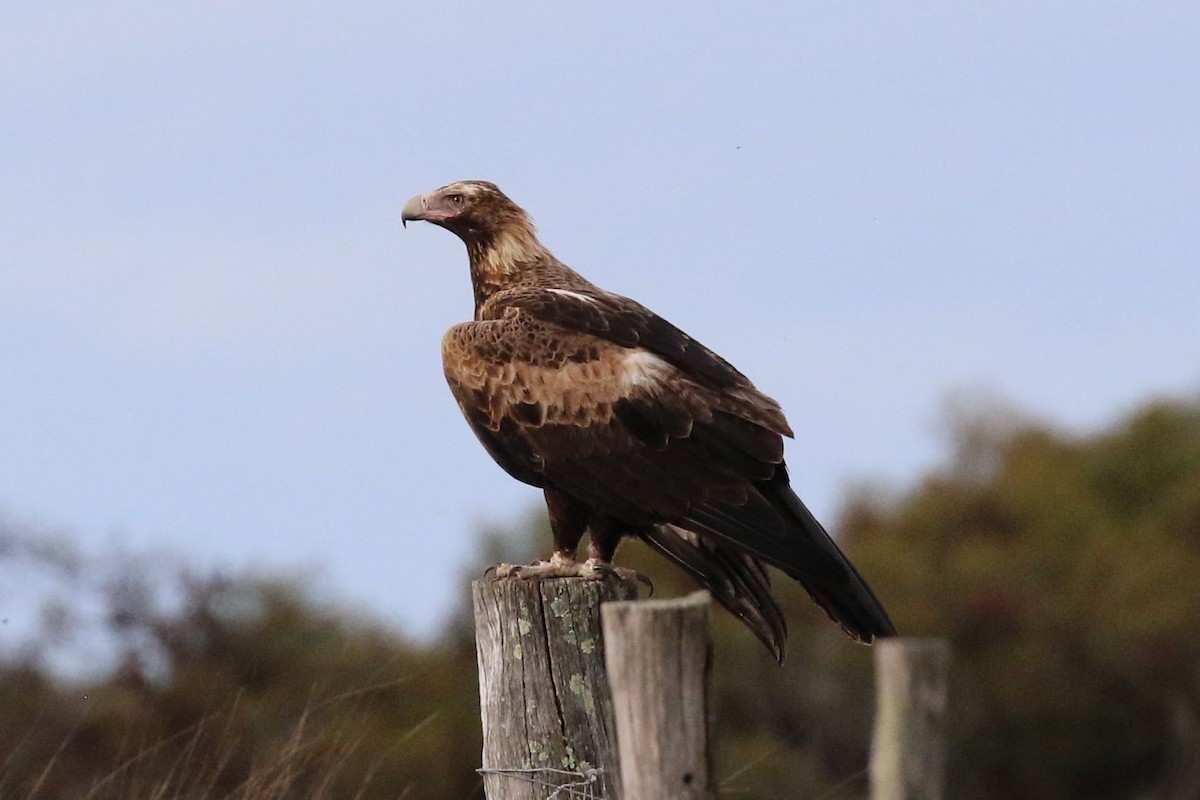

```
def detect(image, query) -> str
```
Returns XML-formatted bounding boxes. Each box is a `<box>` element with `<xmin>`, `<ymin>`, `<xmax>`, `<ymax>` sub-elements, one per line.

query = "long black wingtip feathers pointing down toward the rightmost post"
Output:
<box><xmin>760</xmin><ymin>473</ymin><xmax>896</xmax><ymax>644</ymax></box>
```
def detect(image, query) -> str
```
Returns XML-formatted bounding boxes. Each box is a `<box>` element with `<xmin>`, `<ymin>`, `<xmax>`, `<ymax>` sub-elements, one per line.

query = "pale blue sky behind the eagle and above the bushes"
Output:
<box><xmin>0</xmin><ymin>0</ymin><xmax>1200</xmax><ymax>633</ymax></box>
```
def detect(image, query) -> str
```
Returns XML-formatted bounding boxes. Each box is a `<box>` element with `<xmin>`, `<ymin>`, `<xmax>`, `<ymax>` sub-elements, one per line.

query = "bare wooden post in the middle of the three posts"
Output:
<box><xmin>601</xmin><ymin>591</ymin><xmax>712</xmax><ymax>800</ymax></box>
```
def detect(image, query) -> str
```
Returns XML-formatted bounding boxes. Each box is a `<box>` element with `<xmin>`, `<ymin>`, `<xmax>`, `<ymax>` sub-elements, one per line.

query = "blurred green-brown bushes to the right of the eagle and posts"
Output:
<box><xmin>842</xmin><ymin>402</ymin><xmax>1200</xmax><ymax>799</ymax></box>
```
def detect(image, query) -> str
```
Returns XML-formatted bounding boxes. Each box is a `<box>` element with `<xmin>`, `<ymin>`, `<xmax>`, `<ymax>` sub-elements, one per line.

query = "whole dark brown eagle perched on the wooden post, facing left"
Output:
<box><xmin>401</xmin><ymin>180</ymin><xmax>895</xmax><ymax>662</ymax></box>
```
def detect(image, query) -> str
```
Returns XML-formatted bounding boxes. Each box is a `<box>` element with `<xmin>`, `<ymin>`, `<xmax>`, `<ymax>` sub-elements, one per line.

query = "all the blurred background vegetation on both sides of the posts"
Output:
<box><xmin>0</xmin><ymin>398</ymin><xmax>1200</xmax><ymax>800</ymax></box>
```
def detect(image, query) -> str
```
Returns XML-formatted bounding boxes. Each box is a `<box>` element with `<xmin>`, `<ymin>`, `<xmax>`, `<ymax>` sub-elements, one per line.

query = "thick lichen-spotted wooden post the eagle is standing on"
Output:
<box><xmin>472</xmin><ymin>578</ymin><xmax>637</xmax><ymax>800</ymax></box>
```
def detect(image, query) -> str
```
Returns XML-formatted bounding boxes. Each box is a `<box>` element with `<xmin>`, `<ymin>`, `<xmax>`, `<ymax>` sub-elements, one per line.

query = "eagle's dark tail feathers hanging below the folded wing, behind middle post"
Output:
<box><xmin>642</xmin><ymin>525</ymin><xmax>787</xmax><ymax>663</ymax></box>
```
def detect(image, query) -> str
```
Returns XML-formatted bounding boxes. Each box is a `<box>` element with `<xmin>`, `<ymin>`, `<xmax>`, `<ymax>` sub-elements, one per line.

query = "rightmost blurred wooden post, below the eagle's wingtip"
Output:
<box><xmin>870</xmin><ymin>638</ymin><xmax>950</xmax><ymax>800</ymax></box>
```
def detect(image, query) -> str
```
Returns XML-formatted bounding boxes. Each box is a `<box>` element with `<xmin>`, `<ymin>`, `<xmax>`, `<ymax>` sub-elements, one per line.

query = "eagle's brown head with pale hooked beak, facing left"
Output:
<box><xmin>400</xmin><ymin>181</ymin><xmax>533</xmax><ymax>243</ymax></box>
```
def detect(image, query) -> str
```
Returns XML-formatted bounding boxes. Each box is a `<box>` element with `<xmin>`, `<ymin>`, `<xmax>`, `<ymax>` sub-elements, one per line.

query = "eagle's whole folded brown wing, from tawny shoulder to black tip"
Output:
<box><xmin>443</xmin><ymin>289</ymin><xmax>890</xmax><ymax>640</ymax></box>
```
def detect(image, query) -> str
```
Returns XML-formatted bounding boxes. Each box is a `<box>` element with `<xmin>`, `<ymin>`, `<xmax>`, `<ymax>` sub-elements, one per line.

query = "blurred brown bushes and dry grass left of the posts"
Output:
<box><xmin>0</xmin><ymin>551</ymin><xmax>481</xmax><ymax>800</ymax></box>
